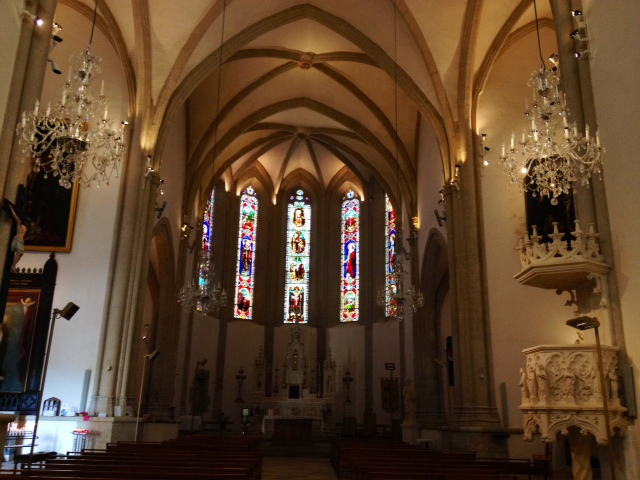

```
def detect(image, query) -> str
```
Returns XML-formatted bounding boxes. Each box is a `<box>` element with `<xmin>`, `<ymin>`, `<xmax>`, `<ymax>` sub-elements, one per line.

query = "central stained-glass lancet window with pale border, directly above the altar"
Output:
<box><xmin>284</xmin><ymin>190</ymin><xmax>311</xmax><ymax>323</ymax></box>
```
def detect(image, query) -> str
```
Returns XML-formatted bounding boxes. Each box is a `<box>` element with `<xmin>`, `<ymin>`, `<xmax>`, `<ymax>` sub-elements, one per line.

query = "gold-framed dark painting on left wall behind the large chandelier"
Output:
<box><xmin>17</xmin><ymin>160</ymin><xmax>79</xmax><ymax>252</ymax></box>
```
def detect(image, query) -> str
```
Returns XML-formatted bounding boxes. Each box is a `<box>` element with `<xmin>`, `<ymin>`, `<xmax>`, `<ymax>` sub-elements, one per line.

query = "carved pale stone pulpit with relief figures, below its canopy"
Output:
<box><xmin>519</xmin><ymin>344</ymin><xmax>629</xmax><ymax>445</ymax></box>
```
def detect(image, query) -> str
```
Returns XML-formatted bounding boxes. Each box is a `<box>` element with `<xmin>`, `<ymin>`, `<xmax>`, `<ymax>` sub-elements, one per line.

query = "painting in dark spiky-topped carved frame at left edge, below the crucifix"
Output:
<box><xmin>0</xmin><ymin>253</ymin><xmax>58</xmax><ymax>415</ymax></box>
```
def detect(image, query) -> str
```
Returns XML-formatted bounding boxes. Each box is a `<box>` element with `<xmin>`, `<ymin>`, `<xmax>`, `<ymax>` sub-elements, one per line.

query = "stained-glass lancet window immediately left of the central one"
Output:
<box><xmin>233</xmin><ymin>187</ymin><xmax>258</xmax><ymax>320</ymax></box>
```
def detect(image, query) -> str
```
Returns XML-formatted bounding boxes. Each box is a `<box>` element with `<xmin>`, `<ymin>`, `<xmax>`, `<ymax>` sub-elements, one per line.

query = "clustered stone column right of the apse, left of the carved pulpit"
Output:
<box><xmin>444</xmin><ymin>174</ymin><xmax>501</xmax><ymax>428</ymax></box>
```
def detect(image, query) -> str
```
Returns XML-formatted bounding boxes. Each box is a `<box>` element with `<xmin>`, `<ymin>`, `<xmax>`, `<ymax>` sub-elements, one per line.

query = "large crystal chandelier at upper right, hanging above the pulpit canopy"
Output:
<box><xmin>499</xmin><ymin>1</ymin><xmax>604</xmax><ymax>205</ymax></box>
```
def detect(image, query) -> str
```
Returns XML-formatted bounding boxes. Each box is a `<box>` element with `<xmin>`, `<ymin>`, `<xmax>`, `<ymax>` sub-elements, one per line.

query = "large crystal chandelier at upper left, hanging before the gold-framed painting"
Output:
<box><xmin>16</xmin><ymin>1</ymin><xmax>127</xmax><ymax>188</ymax></box>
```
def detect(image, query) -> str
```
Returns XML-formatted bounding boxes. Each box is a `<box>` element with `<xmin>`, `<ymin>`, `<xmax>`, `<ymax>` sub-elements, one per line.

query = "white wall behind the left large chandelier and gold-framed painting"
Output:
<box><xmin>19</xmin><ymin>4</ymin><xmax>128</xmax><ymax>407</ymax></box>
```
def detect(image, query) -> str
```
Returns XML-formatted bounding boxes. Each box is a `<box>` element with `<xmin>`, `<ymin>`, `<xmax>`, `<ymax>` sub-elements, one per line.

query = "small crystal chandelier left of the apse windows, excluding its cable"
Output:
<box><xmin>178</xmin><ymin>250</ymin><xmax>227</xmax><ymax>316</ymax></box>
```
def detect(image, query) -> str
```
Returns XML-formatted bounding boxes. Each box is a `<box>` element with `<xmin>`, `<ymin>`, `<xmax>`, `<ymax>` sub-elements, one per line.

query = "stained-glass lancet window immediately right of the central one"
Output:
<box><xmin>340</xmin><ymin>190</ymin><xmax>360</xmax><ymax>322</ymax></box>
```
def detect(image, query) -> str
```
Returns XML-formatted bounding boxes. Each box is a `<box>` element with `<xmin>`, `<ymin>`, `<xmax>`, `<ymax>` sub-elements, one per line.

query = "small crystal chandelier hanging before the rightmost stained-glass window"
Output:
<box><xmin>376</xmin><ymin>232</ymin><xmax>424</xmax><ymax>321</ymax></box>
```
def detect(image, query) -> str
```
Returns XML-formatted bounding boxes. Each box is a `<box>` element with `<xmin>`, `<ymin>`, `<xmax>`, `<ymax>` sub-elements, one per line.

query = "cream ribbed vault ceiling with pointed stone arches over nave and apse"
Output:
<box><xmin>65</xmin><ymin>0</ymin><xmax>551</xmax><ymax>210</ymax></box>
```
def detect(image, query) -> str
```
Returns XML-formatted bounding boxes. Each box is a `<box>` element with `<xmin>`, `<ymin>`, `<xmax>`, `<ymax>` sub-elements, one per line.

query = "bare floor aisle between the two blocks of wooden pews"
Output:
<box><xmin>262</xmin><ymin>457</ymin><xmax>338</xmax><ymax>480</ymax></box>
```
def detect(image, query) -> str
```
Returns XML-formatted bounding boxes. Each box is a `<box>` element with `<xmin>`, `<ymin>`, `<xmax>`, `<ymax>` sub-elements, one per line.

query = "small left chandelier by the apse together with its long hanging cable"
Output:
<box><xmin>178</xmin><ymin>0</ymin><xmax>227</xmax><ymax>316</ymax></box>
